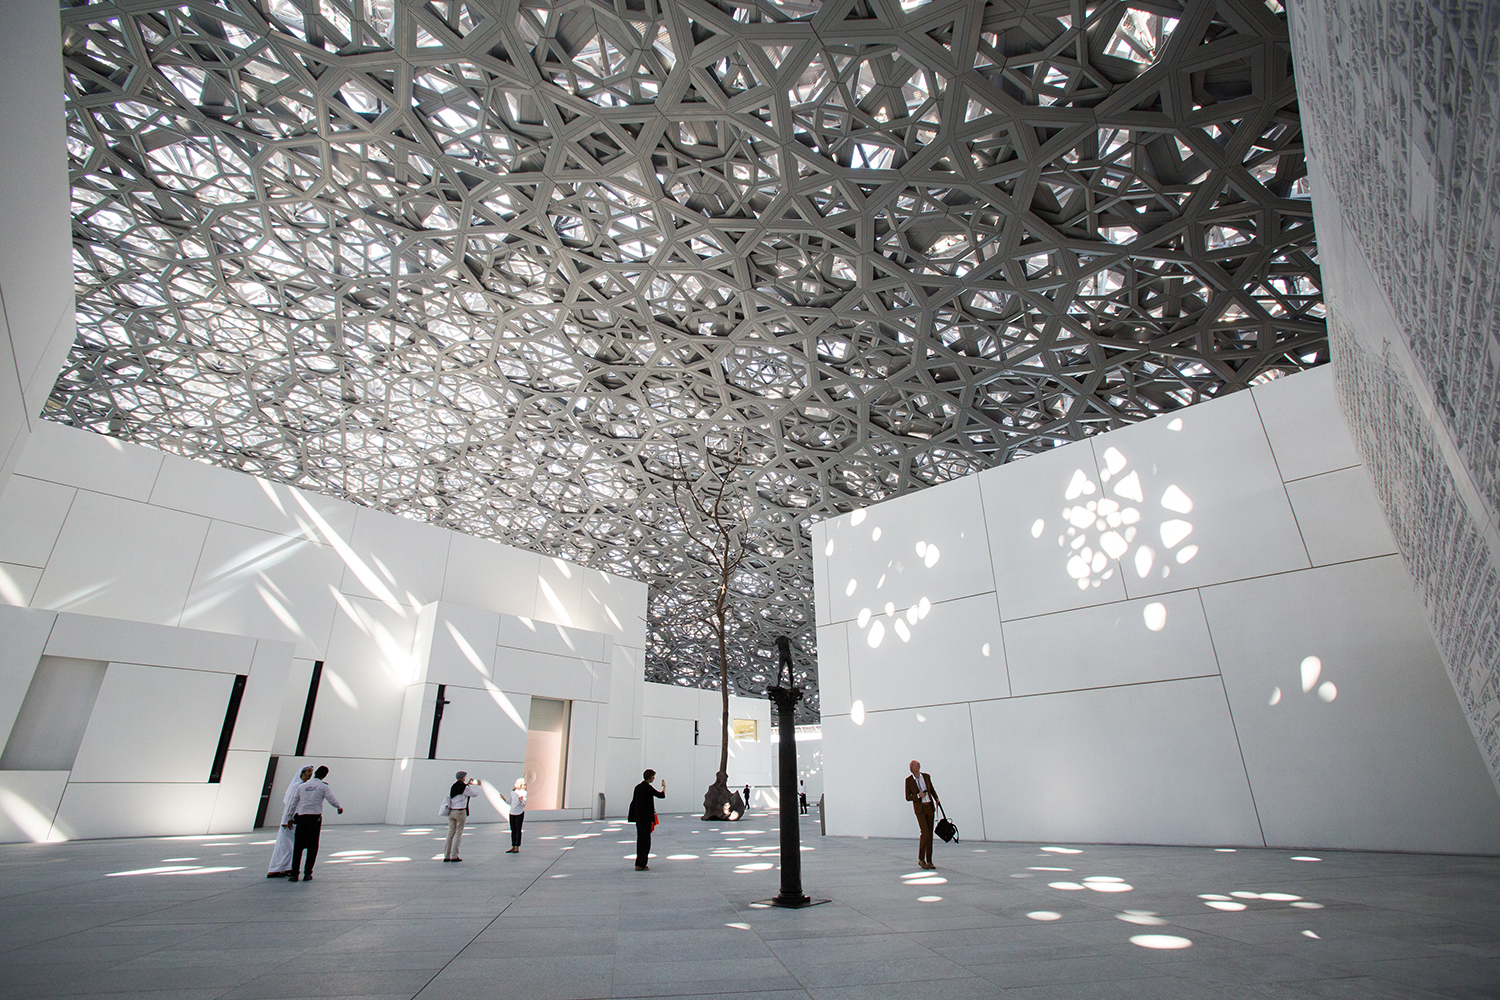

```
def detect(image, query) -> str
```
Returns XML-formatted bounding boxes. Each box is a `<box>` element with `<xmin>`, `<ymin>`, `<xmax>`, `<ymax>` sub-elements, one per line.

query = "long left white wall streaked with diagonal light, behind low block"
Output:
<box><xmin>0</xmin><ymin>421</ymin><xmax>647</xmax><ymax>839</ymax></box>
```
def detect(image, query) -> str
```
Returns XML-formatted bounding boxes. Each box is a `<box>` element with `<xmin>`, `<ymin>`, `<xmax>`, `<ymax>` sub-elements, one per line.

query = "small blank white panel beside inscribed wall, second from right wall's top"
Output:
<box><xmin>1287</xmin><ymin>465</ymin><xmax>1397</xmax><ymax>565</ymax></box>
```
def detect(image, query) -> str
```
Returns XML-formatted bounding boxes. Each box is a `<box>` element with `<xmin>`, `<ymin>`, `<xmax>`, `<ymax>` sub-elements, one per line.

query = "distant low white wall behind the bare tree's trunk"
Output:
<box><xmin>636</xmin><ymin>684</ymin><xmax>776</xmax><ymax>816</ymax></box>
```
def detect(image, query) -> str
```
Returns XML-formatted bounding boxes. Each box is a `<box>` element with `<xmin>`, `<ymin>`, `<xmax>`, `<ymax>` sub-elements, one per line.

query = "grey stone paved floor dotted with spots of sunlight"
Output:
<box><xmin>0</xmin><ymin>816</ymin><xmax>1500</xmax><ymax>1000</ymax></box>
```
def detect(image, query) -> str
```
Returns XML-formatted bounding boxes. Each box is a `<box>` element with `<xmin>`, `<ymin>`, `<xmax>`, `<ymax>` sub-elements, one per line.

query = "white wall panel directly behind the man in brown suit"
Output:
<box><xmin>824</xmin><ymin>705</ymin><xmax>984</xmax><ymax>855</ymax></box>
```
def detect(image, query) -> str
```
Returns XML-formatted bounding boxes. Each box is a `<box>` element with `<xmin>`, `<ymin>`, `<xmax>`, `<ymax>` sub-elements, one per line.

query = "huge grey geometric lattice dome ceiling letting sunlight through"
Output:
<box><xmin>48</xmin><ymin>0</ymin><xmax>1328</xmax><ymax>714</ymax></box>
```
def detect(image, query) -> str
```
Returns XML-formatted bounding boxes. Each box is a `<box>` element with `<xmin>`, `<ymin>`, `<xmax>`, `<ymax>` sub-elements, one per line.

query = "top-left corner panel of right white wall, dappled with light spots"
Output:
<box><xmin>825</xmin><ymin>477</ymin><xmax>995</xmax><ymax>621</ymax></box>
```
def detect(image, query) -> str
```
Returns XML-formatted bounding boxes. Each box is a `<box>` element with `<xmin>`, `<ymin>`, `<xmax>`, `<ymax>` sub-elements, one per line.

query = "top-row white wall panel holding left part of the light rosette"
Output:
<box><xmin>975</xmin><ymin>441</ymin><xmax>1125</xmax><ymax>621</ymax></box>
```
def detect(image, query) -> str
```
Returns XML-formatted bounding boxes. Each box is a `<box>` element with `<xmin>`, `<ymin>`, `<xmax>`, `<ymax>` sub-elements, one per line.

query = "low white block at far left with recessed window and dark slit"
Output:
<box><xmin>0</xmin><ymin>607</ymin><xmax>293</xmax><ymax>843</ymax></box>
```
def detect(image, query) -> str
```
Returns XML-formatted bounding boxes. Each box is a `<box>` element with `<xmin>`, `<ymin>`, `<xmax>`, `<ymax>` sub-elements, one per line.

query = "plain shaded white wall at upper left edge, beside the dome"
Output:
<box><xmin>0</xmin><ymin>0</ymin><xmax>74</xmax><ymax>489</ymax></box>
